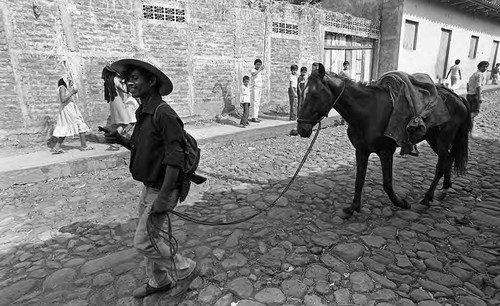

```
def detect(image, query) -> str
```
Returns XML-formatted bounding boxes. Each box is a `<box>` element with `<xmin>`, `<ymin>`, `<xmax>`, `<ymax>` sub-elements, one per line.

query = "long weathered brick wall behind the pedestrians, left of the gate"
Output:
<box><xmin>0</xmin><ymin>0</ymin><xmax>376</xmax><ymax>134</ymax></box>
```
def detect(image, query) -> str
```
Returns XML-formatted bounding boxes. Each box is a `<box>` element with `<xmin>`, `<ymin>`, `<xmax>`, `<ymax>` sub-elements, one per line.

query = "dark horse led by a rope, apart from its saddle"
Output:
<box><xmin>297</xmin><ymin>64</ymin><xmax>472</xmax><ymax>217</ymax></box>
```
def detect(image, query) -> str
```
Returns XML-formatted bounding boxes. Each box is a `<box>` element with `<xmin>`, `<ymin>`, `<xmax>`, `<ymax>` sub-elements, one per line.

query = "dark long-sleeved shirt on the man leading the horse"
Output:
<box><xmin>130</xmin><ymin>95</ymin><xmax>184</xmax><ymax>189</ymax></box>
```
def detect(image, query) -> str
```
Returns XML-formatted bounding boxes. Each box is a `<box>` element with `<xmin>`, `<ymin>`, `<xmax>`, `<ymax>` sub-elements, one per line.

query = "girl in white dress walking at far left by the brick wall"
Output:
<box><xmin>51</xmin><ymin>75</ymin><xmax>94</xmax><ymax>154</ymax></box>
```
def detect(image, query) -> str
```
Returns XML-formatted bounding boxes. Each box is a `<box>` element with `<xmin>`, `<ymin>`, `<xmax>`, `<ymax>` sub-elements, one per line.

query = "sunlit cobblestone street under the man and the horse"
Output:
<box><xmin>0</xmin><ymin>92</ymin><xmax>500</xmax><ymax>306</ymax></box>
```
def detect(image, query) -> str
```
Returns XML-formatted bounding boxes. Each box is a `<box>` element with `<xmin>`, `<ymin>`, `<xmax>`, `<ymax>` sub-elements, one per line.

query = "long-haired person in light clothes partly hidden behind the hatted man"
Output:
<box><xmin>101</xmin><ymin>65</ymin><xmax>132</xmax><ymax>151</ymax></box>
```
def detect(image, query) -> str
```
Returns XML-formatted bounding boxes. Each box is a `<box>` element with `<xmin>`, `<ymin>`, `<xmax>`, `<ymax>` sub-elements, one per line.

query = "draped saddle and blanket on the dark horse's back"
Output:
<box><xmin>376</xmin><ymin>71</ymin><xmax>450</xmax><ymax>156</ymax></box>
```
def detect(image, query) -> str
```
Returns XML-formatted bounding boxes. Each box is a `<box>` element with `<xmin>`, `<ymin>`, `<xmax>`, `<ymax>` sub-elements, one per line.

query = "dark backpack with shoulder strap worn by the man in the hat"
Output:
<box><xmin>153</xmin><ymin>102</ymin><xmax>206</xmax><ymax>184</ymax></box>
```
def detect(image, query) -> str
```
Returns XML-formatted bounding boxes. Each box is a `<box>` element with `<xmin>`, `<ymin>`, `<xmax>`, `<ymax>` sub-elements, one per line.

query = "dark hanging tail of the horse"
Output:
<box><xmin>451</xmin><ymin>97</ymin><xmax>472</xmax><ymax>175</ymax></box>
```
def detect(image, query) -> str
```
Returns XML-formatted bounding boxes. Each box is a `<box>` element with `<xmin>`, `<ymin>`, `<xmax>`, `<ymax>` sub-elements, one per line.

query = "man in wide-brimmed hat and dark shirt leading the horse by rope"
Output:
<box><xmin>106</xmin><ymin>59</ymin><xmax>199</xmax><ymax>298</ymax></box>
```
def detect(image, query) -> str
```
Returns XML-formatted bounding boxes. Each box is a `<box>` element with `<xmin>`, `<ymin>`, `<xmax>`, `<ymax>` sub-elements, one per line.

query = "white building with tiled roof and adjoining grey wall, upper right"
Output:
<box><xmin>379</xmin><ymin>0</ymin><xmax>500</xmax><ymax>88</ymax></box>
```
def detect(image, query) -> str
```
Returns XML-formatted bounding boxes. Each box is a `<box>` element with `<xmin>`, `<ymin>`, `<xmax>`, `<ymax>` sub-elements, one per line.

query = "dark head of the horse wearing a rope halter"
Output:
<box><xmin>297</xmin><ymin>63</ymin><xmax>340</xmax><ymax>137</ymax></box>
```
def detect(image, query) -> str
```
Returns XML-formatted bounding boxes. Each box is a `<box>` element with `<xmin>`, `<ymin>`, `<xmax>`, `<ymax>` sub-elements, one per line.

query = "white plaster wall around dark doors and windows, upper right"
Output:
<box><xmin>398</xmin><ymin>0</ymin><xmax>500</xmax><ymax>88</ymax></box>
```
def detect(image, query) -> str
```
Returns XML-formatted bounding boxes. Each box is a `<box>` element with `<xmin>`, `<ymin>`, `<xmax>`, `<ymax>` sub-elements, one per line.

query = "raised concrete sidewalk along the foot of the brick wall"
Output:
<box><xmin>0</xmin><ymin>110</ymin><xmax>341</xmax><ymax>190</ymax></box>
